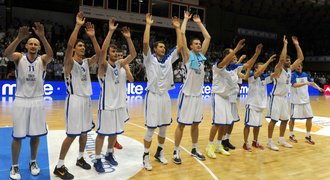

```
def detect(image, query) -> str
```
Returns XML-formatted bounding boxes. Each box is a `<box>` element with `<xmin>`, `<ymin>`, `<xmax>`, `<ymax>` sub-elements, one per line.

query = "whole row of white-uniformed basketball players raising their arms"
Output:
<box><xmin>5</xmin><ymin>11</ymin><xmax>323</xmax><ymax>179</ymax></box>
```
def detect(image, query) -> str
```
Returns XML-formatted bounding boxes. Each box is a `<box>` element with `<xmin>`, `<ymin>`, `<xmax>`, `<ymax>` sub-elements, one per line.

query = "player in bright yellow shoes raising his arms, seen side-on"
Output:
<box><xmin>206</xmin><ymin>39</ymin><xmax>245</xmax><ymax>159</ymax></box>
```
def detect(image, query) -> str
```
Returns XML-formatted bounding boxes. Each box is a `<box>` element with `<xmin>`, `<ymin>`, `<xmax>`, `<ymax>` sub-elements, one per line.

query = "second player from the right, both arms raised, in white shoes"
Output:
<box><xmin>267</xmin><ymin>36</ymin><xmax>304</xmax><ymax>151</ymax></box>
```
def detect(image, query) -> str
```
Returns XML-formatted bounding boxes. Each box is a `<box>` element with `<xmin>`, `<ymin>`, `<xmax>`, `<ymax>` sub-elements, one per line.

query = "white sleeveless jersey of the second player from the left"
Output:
<box><xmin>64</xmin><ymin>59</ymin><xmax>92</xmax><ymax>96</ymax></box>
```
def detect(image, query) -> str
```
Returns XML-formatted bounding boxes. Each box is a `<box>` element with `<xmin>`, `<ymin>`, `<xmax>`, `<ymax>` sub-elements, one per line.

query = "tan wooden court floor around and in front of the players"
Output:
<box><xmin>0</xmin><ymin>96</ymin><xmax>330</xmax><ymax>179</ymax></box>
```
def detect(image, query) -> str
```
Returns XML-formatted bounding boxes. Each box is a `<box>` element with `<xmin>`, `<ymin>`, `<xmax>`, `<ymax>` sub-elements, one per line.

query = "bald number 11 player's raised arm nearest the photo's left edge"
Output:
<box><xmin>4</xmin><ymin>26</ymin><xmax>30</xmax><ymax>64</ymax></box>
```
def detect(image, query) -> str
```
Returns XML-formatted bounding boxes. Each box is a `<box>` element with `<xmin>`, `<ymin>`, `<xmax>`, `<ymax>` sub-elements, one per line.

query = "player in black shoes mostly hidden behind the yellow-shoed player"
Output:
<box><xmin>220</xmin><ymin>44</ymin><xmax>263</xmax><ymax>150</ymax></box>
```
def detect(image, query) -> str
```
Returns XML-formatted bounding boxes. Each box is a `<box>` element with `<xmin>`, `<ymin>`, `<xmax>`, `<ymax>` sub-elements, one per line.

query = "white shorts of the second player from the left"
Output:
<box><xmin>65</xmin><ymin>94</ymin><xmax>94</xmax><ymax>136</ymax></box>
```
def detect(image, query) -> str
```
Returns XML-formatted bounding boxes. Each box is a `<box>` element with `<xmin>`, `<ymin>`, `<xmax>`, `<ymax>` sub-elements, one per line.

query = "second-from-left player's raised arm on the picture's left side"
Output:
<box><xmin>64</xmin><ymin>12</ymin><xmax>85</xmax><ymax>76</ymax></box>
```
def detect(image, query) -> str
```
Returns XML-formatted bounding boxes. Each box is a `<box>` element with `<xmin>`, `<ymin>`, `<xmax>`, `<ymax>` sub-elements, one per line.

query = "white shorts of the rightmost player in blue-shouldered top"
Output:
<box><xmin>291</xmin><ymin>103</ymin><xmax>313</xmax><ymax>120</ymax></box>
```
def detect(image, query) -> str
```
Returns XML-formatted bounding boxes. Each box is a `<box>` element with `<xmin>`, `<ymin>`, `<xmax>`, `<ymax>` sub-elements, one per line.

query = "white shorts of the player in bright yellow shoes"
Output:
<box><xmin>212</xmin><ymin>93</ymin><xmax>234</xmax><ymax>125</ymax></box>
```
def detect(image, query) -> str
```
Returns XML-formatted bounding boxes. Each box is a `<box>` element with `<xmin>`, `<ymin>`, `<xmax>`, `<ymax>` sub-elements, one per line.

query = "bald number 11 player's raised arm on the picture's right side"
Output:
<box><xmin>32</xmin><ymin>22</ymin><xmax>53</xmax><ymax>67</ymax></box>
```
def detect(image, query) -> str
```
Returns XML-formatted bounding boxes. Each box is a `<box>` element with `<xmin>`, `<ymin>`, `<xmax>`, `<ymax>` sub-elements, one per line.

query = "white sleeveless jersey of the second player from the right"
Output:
<box><xmin>271</xmin><ymin>68</ymin><xmax>291</xmax><ymax>96</ymax></box>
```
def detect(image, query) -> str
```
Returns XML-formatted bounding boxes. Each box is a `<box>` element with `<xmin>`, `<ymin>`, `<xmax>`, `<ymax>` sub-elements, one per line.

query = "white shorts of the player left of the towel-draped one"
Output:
<box><xmin>144</xmin><ymin>91</ymin><xmax>172</xmax><ymax>128</ymax></box>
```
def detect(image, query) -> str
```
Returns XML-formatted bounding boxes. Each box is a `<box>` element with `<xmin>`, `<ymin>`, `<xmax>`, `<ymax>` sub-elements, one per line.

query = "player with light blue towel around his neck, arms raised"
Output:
<box><xmin>173</xmin><ymin>11</ymin><xmax>211</xmax><ymax>164</ymax></box>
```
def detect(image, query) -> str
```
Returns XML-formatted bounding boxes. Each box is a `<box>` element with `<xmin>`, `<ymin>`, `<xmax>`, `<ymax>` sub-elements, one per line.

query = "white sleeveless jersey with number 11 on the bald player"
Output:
<box><xmin>16</xmin><ymin>54</ymin><xmax>46</xmax><ymax>98</ymax></box>
